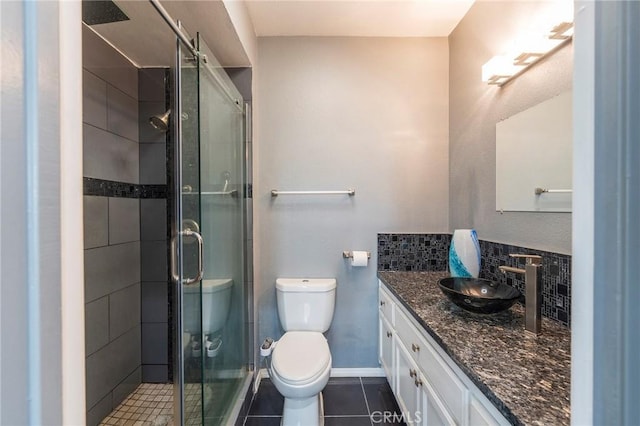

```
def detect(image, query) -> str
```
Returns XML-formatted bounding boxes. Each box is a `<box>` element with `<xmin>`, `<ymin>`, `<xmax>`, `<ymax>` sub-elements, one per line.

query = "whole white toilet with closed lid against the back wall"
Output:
<box><xmin>269</xmin><ymin>278</ymin><xmax>336</xmax><ymax>426</ymax></box>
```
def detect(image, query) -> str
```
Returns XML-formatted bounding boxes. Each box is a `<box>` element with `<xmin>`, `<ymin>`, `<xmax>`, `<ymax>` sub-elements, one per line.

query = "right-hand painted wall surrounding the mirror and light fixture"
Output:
<box><xmin>449</xmin><ymin>2</ymin><xmax>573</xmax><ymax>254</ymax></box>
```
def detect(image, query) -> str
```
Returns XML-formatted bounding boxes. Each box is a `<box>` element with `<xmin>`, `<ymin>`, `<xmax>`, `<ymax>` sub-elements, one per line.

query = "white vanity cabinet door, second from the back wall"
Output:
<box><xmin>395</xmin><ymin>342</ymin><xmax>422</xmax><ymax>425</ymax></box>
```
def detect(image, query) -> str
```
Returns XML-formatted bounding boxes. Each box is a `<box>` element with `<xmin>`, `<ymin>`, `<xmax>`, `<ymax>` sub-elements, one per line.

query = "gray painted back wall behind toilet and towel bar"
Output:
<box><xmin>253</xmin><ymin>37</ymin><xmax>449</xmax><ymax>368</ymax></box>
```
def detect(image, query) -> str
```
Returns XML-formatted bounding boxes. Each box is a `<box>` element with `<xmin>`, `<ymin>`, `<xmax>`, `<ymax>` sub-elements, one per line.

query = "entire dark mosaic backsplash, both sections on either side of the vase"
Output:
<box><xmin>378</xmin><ymin>234</ymin><xmax>571</xmax><ymax>326</ymax></box>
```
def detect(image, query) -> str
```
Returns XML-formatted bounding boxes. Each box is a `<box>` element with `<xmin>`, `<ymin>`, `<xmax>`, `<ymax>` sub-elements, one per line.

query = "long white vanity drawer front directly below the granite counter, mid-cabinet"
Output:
<box><xmin>396</xmin><ymin>310</ymin><xmax>467</xmax><ymax>424</ymax></box>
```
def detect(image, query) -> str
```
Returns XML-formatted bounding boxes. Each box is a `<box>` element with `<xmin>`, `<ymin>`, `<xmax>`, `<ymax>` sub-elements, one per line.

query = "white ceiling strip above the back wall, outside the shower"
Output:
<box><xmin>245</xmin><ymin>0</ymin><xmax>474</xmax><ymax>37</ymax></box>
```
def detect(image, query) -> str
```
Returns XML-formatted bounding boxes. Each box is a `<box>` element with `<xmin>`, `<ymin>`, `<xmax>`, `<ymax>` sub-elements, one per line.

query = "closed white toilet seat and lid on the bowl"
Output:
<box><xmin>271</xmin><ymin>331</ymin><xmax>331</xmax><ymax>386</ymax></box>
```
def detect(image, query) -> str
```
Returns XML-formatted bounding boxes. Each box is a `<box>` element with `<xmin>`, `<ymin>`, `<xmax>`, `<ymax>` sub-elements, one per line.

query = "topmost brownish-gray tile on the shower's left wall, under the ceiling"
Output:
<box><xmin>82</xmin><ymin>26</ymin><xmax>138</xmax><ymax>99</ymax></box>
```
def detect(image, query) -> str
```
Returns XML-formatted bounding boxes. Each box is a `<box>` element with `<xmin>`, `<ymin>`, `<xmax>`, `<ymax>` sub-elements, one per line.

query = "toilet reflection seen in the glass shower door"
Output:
<box><xmin>183</xmin><ymin>278</ymin><xmax>233</xmax><ymax>358</ymax></box>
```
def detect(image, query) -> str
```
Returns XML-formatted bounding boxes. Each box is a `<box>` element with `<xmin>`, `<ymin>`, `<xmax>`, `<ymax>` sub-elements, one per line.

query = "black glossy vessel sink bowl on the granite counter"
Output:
<box><xmin>438</xmin><ymin>277</ymin><xmax>520</xmax><ymax>314</ymax></box>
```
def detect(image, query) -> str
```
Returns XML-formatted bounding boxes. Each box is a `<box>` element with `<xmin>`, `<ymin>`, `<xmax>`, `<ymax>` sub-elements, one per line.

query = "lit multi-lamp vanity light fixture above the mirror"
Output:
<box><xmin>482</xmin><ymin>21</ymin><xmax>573</xmax><ymax>86</ymax></box>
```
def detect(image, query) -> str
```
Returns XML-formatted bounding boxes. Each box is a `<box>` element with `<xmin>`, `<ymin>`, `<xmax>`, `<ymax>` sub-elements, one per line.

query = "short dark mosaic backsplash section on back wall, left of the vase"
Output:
<box><xmin>378</xmin><ymin>234</ymin><xmax>451</xmax><ymax>271</ymax></box>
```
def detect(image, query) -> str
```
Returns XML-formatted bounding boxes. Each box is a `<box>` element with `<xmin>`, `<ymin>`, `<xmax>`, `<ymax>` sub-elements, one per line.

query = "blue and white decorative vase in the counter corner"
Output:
<box><xmin>449</xmin><ymin>229</ymin><xmax>480</xmax><ymax>278</ymax></box>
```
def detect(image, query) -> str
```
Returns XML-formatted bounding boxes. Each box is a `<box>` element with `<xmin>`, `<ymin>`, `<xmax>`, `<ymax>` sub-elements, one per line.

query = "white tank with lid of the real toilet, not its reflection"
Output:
<box><xmin>276</xmin><ymin>278</ymin><xmax>336</xmax><ymax>333</ymax></box>
